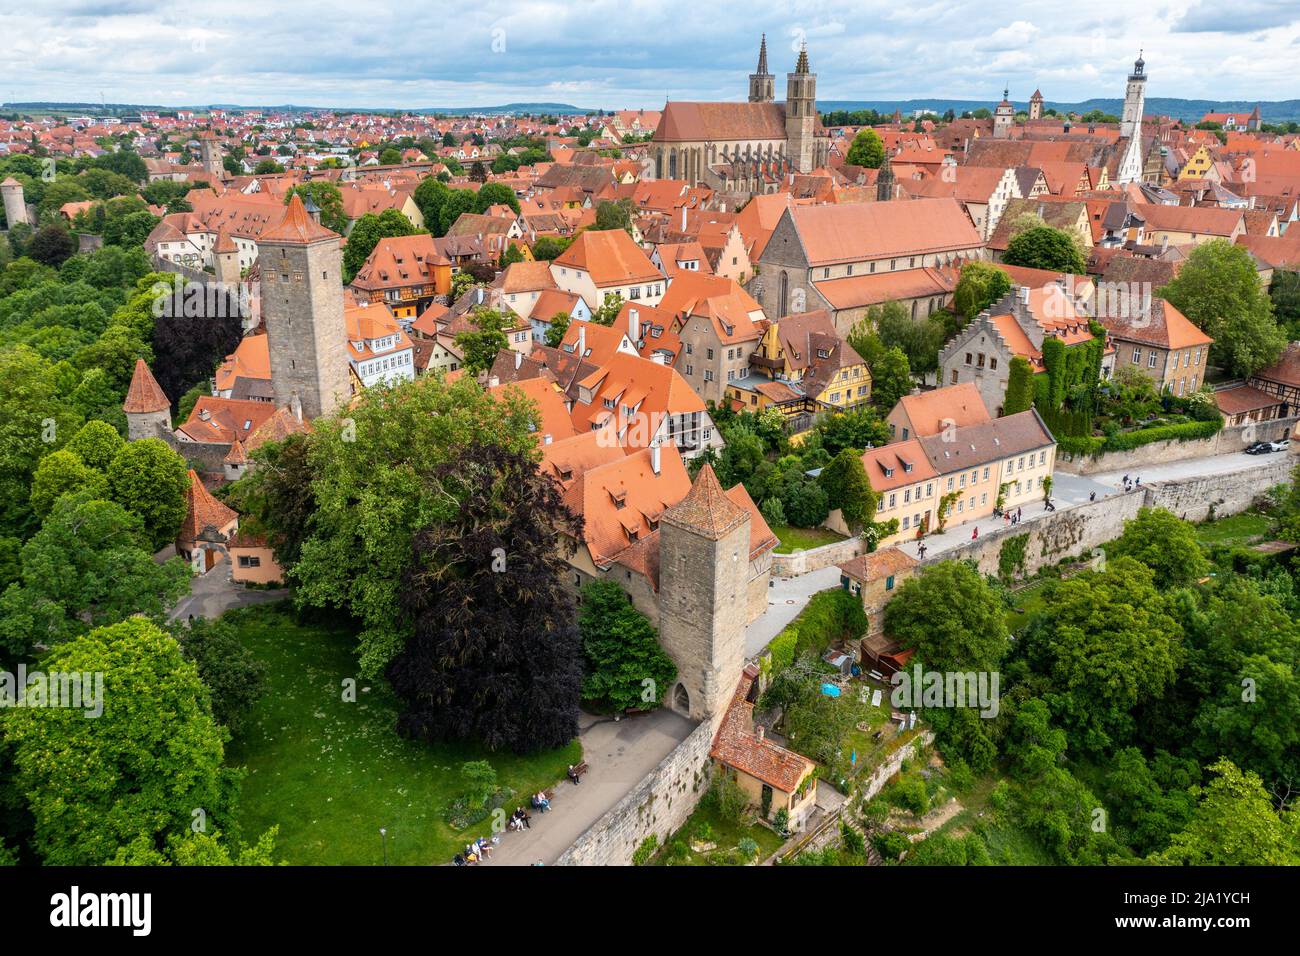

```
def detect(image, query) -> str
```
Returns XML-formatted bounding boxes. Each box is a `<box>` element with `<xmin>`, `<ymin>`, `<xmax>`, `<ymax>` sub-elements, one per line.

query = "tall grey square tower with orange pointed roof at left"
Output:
<box><xmin>257</xmin><ymin>194</ymin><xmax>352</xmax><ymax>419</ymax></box>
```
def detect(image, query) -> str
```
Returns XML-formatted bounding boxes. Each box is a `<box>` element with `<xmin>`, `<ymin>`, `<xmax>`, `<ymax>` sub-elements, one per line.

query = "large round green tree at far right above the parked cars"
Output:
<box><xmin>1156</xmin><ymin>239</ymin><xmax>1286</xmax><ymax>378</ymax></box>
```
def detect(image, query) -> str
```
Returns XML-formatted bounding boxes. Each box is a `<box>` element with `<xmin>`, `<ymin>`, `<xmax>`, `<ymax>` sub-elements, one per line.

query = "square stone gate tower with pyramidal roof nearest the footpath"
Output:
<box><xmin>659</xmin><ymin>464</ymin><xmax>750</xmax><ymax>721</ymax></box>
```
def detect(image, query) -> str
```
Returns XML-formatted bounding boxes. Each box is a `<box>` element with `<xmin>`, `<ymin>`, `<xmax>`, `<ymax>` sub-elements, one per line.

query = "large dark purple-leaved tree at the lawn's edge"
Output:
<box><xmin>387</xmin><ymin>445</ymin><xmax>582</xmax><ymax>753</ymax></box>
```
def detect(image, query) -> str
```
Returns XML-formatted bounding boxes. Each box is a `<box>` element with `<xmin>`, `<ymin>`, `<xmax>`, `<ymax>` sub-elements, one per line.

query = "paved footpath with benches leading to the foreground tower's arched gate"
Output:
<box><xmin>484</xmin><ymin>708</ymin><xmax>696</xmax><ymax>866</ymax></box>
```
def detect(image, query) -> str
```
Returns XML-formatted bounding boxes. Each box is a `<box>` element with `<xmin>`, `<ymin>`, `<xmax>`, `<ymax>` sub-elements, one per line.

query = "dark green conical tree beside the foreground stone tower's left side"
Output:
<box><xmin>577</xmin><ymin>580</ymin><xmax>677</xmax><ymax>713</ymax></box>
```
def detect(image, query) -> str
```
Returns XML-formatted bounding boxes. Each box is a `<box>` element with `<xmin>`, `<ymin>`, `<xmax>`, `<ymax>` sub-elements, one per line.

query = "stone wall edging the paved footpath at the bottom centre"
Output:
<box><xmin>555</xmin><ymin>721</ymin><xmax>715</xmax><ymax>866</ymax></box>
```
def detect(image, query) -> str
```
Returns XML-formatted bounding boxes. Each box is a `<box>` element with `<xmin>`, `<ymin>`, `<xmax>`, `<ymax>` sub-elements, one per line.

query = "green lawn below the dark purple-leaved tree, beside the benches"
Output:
<box><xmin>225</xmin><ymin>605</ymin><xmax>581</xmax><ymax>865</ymax></box>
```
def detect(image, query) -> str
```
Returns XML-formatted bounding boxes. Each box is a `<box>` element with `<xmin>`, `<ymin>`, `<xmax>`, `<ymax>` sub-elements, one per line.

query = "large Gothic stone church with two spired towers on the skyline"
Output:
<box><xmin>650</xmin><ymin>36</ymin><xmax>831</xmax><ymax>196</ymax></box>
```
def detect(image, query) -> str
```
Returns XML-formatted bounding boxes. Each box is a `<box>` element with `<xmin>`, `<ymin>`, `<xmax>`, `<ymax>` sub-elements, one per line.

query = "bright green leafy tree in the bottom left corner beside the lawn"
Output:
<box><xmin>3</xmin><ymin>619</ymin><xmax>238</xmax><ymax>866</ymax></box>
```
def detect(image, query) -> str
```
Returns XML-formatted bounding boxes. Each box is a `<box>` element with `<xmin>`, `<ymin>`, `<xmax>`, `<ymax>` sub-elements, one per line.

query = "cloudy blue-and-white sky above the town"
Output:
<box><xmin>0</xmin><ymin>0</ymin><xmax>1300</xmax><ymax>108</ymax></box>
